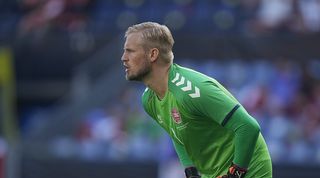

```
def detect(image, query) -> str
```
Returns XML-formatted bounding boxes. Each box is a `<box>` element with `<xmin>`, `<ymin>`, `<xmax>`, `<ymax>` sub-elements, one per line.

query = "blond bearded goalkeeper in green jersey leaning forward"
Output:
<box><xmin>122</xmin><ymin>22</ymin><xmax>272</xmax><ymax>178</ymax></box>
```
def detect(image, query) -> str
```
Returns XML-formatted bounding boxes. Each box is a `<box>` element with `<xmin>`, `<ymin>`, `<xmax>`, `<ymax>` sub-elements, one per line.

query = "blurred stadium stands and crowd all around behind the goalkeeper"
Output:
<box><xmin>0</xmin><ymin>0</ymin><xmax>320</xmax><ymax>178</ymax></box>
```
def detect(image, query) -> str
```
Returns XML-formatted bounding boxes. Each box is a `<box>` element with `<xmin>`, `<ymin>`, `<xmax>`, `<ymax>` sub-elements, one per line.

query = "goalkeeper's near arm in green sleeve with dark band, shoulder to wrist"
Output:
<box><xmin>186</xmin><ymin>82</ymin><xmax>260</xmax><ymax>177</ymax></box>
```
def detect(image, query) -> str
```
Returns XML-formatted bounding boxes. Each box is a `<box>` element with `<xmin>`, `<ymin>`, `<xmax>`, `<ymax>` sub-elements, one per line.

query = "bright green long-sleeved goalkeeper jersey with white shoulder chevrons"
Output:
<box><xmin>142</xmin><ymin>64</ymin><xmax>271</xmax><ymax>177</ymax></box>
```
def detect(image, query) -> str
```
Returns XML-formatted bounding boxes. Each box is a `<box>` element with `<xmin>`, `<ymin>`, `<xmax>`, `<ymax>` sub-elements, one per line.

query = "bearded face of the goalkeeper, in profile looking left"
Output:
<box><xmin>121</xmin><ymin>33</ymin><xmax>151</xmax><ymax>81</ymax></box>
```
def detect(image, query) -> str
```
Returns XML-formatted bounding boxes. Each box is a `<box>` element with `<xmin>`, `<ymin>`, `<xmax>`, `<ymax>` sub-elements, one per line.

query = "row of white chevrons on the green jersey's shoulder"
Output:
<box><xmin>171</xmin><ymin>73</ymin><xmax>200</xmax><ymax>98</ymax></box>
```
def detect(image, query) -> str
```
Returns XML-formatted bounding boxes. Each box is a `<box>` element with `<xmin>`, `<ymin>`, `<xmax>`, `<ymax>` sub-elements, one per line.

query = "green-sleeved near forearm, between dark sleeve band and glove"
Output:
<box><xmin>225</xmin><ymin>107</ymin><xmax>260</xmax><ymax>168</ymax></box>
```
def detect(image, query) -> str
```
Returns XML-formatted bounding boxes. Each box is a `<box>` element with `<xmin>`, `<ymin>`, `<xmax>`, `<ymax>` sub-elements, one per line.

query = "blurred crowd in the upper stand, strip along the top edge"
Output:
<box><xmin>0</xmin><ymin>0</ymin><xmax>320</xmax><ymax>39</ymax></box>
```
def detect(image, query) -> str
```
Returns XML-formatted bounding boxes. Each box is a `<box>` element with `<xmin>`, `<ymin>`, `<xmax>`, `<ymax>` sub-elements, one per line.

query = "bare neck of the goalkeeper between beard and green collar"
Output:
<box><xmin>143</xmin><ymin>65</ymin><xmax>170</xmax><ymax>99</ymax></box>
